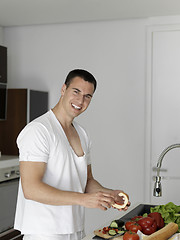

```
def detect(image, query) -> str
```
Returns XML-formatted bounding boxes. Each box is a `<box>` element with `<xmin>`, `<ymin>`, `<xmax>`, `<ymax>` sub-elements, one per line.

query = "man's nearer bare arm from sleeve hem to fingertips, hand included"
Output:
<box><xmin>20</xmin><ymin>161</ymin><xmax>114</xmax><ymax>210</ymax></box>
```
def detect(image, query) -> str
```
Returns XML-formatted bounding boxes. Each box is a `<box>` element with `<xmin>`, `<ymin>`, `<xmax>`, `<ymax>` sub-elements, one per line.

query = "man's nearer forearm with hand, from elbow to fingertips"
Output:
<box><xmin>25</xmin><ymin>181</ymin><xmax>113</xmax><ymax>210</ymax></box>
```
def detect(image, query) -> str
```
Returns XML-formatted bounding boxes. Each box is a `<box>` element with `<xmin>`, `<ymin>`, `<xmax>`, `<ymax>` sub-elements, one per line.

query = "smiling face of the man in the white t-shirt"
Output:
<box><xmin>61</xmin><ymin>77</ymin><xmax>94</xmax><ymax>118</ymax></box>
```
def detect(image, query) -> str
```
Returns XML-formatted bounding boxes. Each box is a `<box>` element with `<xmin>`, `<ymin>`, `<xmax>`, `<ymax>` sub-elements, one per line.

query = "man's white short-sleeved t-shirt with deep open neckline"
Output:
<box><xmin>14</xmin><ymin>110</ymin><xmax>90</xmax><ymax>234</ymax></box>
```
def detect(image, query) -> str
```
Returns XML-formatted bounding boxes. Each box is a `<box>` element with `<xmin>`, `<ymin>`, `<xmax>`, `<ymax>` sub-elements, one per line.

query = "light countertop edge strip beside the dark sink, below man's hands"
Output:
<box><xmin>83</xmin><ymin>203</ymin><xmax>140</xmax><ymax>240</ymax></box>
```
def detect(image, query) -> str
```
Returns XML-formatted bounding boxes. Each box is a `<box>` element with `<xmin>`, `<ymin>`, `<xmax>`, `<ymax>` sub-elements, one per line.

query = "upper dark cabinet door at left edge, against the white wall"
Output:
<box><xmin>0</xmin><ymin>46</ymin><xmax>7</xmax><ymax>83</ymax></box>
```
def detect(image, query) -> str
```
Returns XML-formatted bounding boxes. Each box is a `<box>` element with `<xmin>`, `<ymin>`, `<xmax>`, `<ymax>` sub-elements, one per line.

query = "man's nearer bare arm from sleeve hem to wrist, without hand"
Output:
<box><xmin>20</xmin><ymin>161</ymin><xmax>81</xmax><ymax>205</ymax></box>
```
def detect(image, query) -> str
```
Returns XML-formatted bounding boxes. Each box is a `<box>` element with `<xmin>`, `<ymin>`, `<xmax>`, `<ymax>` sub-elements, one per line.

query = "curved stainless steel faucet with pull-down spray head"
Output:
<box><xmin>153</xmin><ymin>143</ymin><xmax>180</xmax><ymax>197</ymax></box>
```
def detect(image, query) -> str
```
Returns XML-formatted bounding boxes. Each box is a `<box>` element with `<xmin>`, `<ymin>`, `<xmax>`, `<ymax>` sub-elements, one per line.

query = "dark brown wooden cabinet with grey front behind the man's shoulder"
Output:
<box><xmin>0</xmin><ymin>89</ymin><xmax>48</xmax><ymax>155</ymax></box>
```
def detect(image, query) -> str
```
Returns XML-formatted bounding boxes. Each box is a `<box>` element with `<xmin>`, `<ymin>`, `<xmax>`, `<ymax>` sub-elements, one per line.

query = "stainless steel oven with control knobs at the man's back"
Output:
<box><xmin>0</xmin><ymin>155</ymin><xmax>19</xmax><ymax>234</ymax></box>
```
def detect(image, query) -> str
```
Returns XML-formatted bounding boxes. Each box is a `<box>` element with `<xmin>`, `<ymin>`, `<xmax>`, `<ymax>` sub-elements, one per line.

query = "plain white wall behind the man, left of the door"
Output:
<box><xmin>4</xmin><ymin>19</ymin><xmax>147</xmax><ymax>232</ymax></box>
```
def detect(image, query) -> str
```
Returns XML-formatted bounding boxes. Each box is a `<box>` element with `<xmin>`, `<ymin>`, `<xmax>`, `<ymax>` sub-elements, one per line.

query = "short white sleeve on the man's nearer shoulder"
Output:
<box><xmin>17</xmin><ymin>122</ymin><xmax>49</xmax><ymax>163</ymax></box>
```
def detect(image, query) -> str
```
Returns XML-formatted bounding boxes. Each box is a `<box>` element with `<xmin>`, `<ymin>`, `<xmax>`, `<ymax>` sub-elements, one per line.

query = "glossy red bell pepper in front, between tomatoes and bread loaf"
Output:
<box><xmin>138</xmin><ymin>217</ymin><xmax>157</xmax><ymax>235</ymax></box>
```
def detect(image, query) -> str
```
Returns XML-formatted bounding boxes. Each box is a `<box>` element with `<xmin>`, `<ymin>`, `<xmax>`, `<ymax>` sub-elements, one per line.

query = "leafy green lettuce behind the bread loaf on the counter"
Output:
<box><xmin>150</xmin><ymin>202</ymin><xmax>180</xmax><ymax>232</ymax></box>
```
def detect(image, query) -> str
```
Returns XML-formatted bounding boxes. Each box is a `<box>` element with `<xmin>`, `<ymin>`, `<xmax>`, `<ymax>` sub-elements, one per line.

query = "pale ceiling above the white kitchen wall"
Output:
<box><xmin>0</xmin><ymin>0</ymin><xmax>180</xmax><ymax>27</ymax></box>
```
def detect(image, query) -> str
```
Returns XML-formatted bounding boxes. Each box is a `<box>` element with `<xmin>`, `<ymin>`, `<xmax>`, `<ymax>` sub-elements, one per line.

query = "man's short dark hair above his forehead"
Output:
<box><xmin>65</xmin><ymin>69</ymin><xmax>97</xmax><ymax>92</ymax></box>
